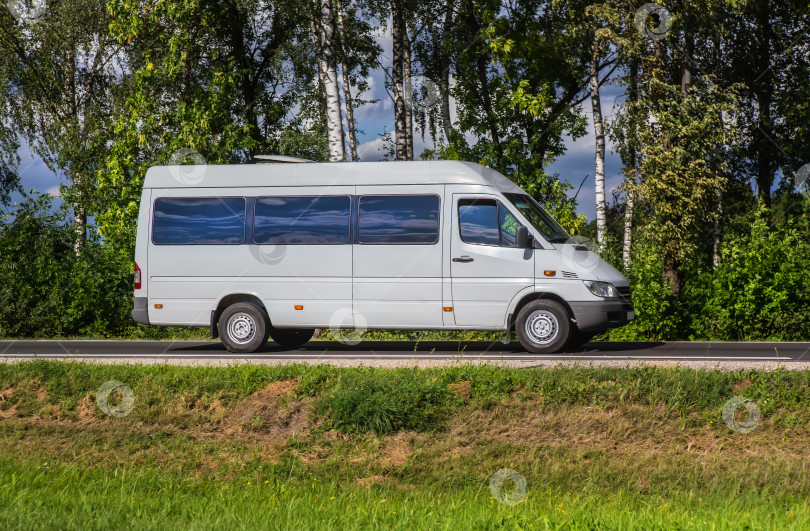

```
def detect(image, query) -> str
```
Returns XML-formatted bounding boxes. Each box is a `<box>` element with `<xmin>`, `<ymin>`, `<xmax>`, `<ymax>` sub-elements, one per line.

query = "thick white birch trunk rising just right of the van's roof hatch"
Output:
<box><xmin>318</xmin><ymin>0</ymin><xmax>346</xmax><ymax>162</ymax></box>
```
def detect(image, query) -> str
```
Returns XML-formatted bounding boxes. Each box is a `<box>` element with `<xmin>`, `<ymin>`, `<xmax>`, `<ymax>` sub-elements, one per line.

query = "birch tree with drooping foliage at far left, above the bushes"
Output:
<box><xmin>0</xmin><ymin>0</ymin><xmax>120</xmax><ymax>253</ymax></box>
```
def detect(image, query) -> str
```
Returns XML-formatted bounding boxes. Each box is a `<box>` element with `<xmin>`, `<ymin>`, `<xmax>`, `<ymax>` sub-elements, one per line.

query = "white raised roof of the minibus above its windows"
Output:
<box><xmin>144</xmin><ymin>160</ymin><xmax>522</xmax><ymax>192</ymax></box>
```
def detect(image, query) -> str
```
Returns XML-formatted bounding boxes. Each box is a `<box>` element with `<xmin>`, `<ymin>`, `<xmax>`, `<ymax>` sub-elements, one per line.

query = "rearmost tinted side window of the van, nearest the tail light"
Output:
<box><xmin>152</xmin><ymin>197</ymin><xmax>246</xmax><ymax>245</ymax></box>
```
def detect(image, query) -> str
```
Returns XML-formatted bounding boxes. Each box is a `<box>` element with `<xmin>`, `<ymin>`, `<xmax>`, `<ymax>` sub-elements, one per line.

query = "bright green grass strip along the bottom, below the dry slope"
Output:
<box><xmin>0</xmin><ymin>460</ymin><xmax>810</xmax><ymax>530</ymax></box>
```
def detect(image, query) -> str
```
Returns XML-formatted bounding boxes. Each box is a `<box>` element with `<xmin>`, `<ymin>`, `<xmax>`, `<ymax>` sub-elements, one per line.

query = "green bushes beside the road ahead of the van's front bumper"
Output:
<box><xmin>608</xmin><ymin>198</ymin><xmax>810</xmax><ymax>341</ymax></box>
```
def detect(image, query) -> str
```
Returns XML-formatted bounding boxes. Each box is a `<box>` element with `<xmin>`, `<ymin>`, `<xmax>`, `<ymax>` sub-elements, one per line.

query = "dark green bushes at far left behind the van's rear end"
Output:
<box><xmin>0</xmin><ymin>195</ymin><xmax>132</xmax><ymax>337</ymax></box>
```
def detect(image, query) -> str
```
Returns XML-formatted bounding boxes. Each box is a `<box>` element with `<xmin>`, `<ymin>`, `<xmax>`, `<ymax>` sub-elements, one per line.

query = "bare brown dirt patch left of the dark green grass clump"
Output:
<box><xmin>221</xmin><ymin>380</ymin><xmax>313</xmax><ymax>438</ymax></box>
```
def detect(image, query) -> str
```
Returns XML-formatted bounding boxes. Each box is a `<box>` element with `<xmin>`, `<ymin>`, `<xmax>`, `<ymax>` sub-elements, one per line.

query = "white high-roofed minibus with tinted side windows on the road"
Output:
<box><xmin>132</xmin><ymin>161</ymin><xmax>633</xmax><ymax>353</ymax></box>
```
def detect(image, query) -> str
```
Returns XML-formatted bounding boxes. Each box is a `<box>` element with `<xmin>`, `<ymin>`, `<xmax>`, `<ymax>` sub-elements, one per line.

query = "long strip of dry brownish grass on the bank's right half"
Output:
<box><xmin>436</xmin><ymin>401</ymin><xmax>810</xmax><ymax>460</ymax></box>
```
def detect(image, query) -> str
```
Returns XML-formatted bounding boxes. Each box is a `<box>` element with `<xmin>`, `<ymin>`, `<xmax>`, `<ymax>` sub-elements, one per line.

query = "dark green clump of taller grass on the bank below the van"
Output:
<box><xmin>319</xmin><ymin>369</ymin><xmax>452</xmax><ymax>434</ymax></box>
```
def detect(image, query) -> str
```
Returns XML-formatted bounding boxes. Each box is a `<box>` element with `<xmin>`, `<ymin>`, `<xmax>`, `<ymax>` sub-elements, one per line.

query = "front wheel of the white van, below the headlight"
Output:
<box><xmin>515</xmin><ymin>299</ymin><xmax>571</xmax><ymax>354</ymax></box>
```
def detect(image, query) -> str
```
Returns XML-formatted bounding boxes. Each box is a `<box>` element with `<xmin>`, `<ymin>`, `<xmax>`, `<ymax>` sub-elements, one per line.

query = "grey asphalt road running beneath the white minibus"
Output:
<box><xmin>0</xmin><ymin>340</ymin><xmax>810</xmax><ymax>364</ymax></box>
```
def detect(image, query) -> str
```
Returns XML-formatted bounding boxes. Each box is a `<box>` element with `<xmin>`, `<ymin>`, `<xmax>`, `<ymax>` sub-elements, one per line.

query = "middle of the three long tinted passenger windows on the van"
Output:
<box><xmin>253</xmin><ymin>196</ymin><xmax>351</xmax><ymax>245</ymax></box>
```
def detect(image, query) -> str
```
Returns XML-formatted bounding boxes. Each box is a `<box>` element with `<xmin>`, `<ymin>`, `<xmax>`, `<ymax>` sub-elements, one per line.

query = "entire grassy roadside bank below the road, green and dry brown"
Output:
<box><xmin>0</xmin><ymin>361</ymin><xmax>810</xmax><ymax>529</ymax></box>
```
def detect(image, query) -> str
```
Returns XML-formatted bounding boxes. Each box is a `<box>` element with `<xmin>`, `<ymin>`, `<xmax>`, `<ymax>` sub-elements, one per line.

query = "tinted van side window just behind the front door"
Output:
<box><xmin>357</xmin><ymin>195</ymin><xmax>439</xmax><ymax>244</ymax></box>
